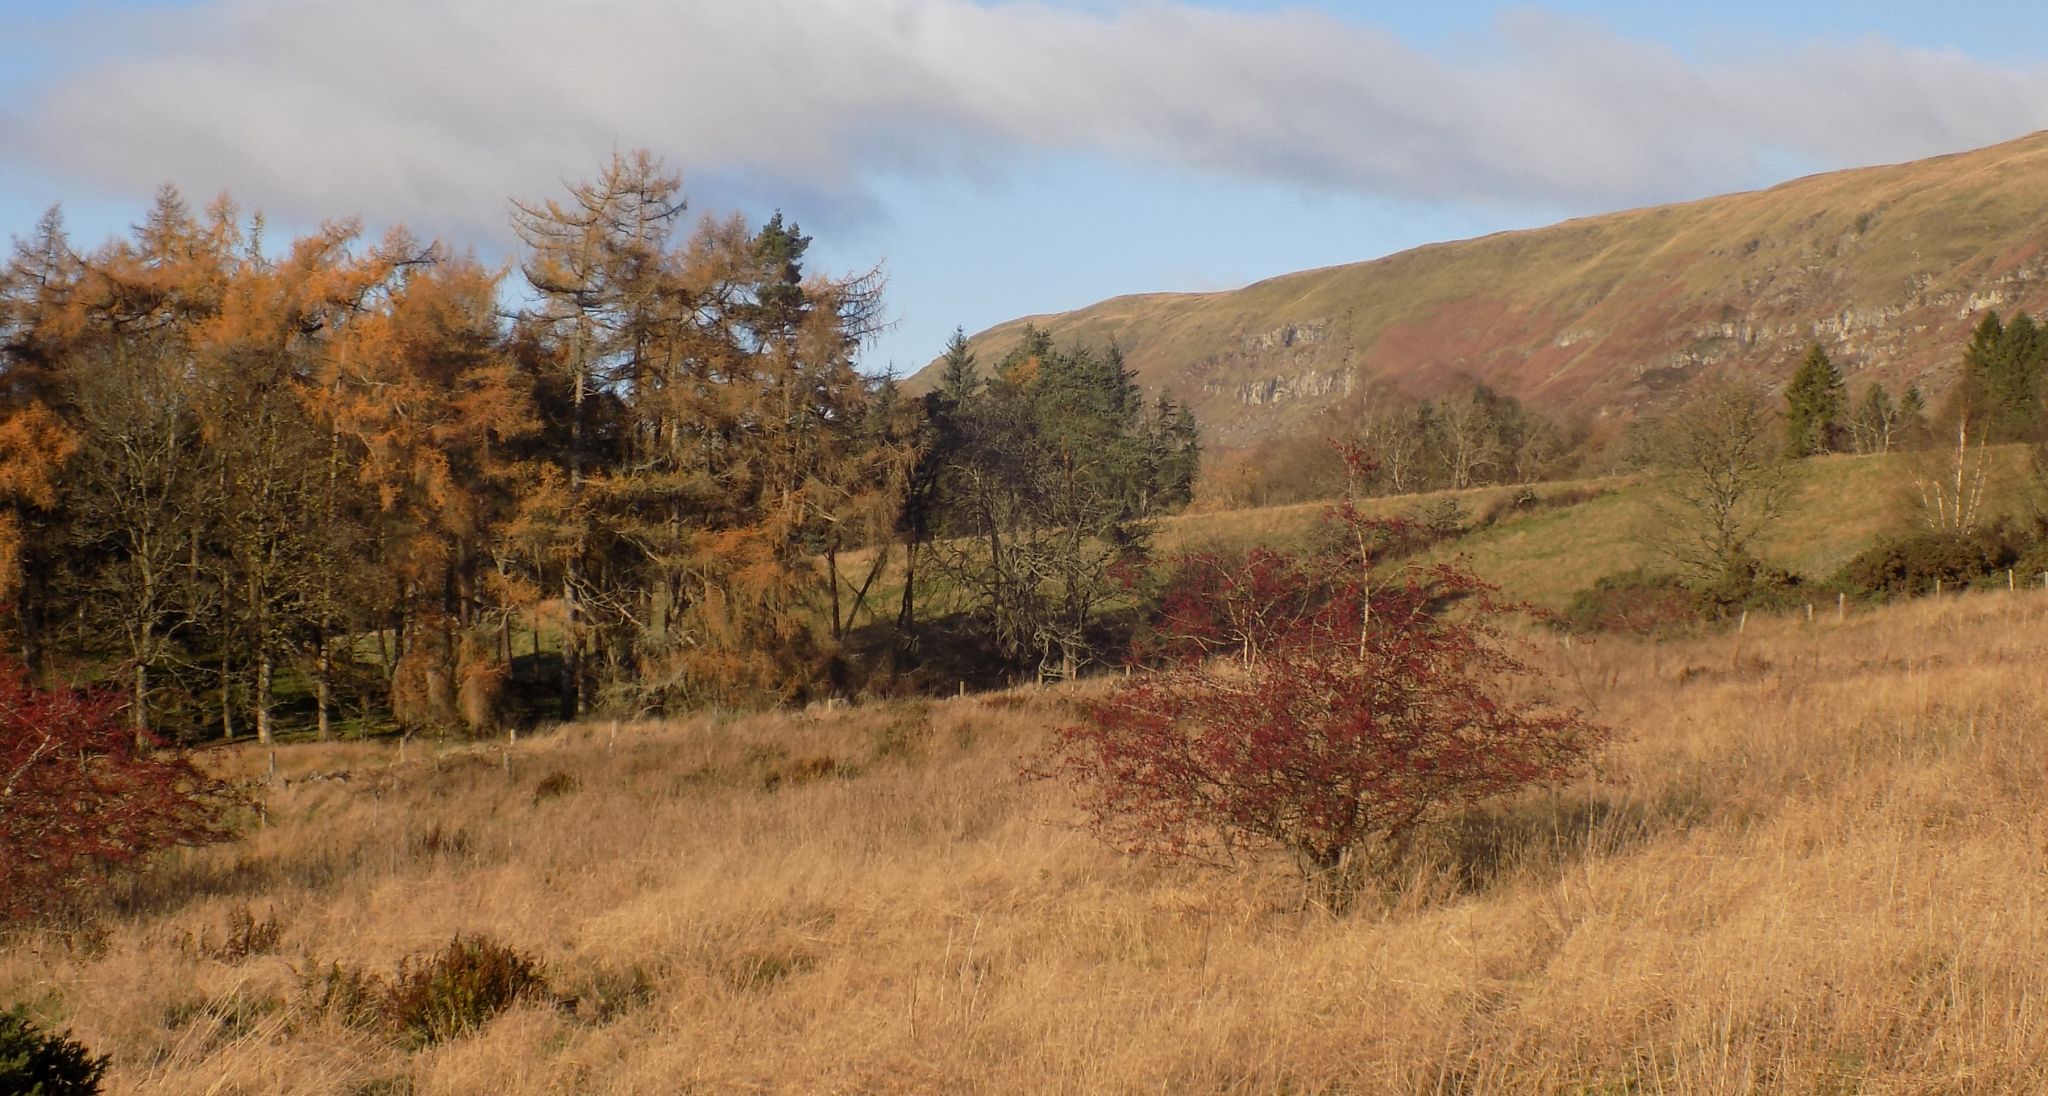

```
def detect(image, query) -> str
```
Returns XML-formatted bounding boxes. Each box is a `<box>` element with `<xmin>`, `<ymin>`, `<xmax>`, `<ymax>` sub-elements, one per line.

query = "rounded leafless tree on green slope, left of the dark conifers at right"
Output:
<box><xmin>1640</xmin><ymin>379</ymin><xmax>1792</xmax><ymax>584</ymax></box>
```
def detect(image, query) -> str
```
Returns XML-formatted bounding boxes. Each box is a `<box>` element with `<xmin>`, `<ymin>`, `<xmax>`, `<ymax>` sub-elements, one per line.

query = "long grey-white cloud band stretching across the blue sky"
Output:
<box><xmin>0</xmin><ymin>0</ymin><xmax>2048</xmax><ymax>234</ymax></box>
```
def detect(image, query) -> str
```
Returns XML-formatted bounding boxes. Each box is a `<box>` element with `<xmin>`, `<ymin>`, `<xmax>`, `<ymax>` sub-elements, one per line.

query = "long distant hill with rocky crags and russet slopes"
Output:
<box><xmin>911</xmin><ymin>131</ymin><xmax>2048</xmax><ymax>445</ymax></box>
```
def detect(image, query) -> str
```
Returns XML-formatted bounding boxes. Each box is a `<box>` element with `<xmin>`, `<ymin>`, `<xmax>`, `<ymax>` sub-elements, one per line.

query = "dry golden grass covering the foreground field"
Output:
<box><xmin>12</xmin><ymin>594</ymin><xmax>2048</xmax><ymax>1096</ymax></box>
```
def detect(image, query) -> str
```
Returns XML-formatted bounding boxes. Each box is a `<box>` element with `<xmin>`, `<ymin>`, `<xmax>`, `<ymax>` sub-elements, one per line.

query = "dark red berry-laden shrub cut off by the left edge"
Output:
<box><xmin>0</xmin><ymin>664</ymin><xmax>238</xmax><ymax>920</ymax></box>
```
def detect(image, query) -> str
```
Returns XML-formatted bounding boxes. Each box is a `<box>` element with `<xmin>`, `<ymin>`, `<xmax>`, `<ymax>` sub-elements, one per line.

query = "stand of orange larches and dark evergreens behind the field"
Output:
<box><xmin>0</xmin><ymin>152</ymin><xmax>1198</xmax><ymax>740</ymax></box>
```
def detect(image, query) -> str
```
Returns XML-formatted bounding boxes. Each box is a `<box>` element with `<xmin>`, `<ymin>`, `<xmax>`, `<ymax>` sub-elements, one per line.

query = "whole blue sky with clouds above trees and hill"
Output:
<box><xmin>0</xmin><ymin>0</ymin><xmax>2048</xmax><ymax>373</ymax></box>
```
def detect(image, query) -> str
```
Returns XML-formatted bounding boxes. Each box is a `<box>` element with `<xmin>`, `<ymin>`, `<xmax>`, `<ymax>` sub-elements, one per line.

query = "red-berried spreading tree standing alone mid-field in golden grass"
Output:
<box><xmin>1034</xmin><ymin>506</ymin><xmax>1608</xmax><ymax>910</ymax></box>
